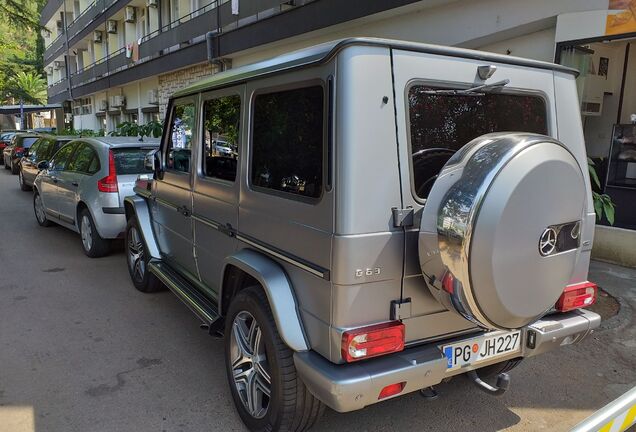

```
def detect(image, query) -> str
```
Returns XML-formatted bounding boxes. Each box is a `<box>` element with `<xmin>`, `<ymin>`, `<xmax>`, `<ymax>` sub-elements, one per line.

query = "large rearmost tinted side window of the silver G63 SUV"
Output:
<box><xmin>251</xmin><ymin>86</ymin><xmax>324</xmax><ymax>199</ymax></box>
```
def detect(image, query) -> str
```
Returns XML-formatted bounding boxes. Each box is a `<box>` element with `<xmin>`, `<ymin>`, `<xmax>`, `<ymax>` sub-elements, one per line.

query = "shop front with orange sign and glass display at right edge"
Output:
<box><xmin>555</xmin><ymin>0</ymin><xmax>636</xmax><ymax>266</ymax></box>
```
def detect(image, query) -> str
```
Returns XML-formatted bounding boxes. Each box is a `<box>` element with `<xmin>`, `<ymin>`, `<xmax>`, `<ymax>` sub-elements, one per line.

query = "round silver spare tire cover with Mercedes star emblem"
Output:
<box><xmin>419</xmin><ymin>133</ymin><xmax>587</xmax><ymax>329</ymax></box>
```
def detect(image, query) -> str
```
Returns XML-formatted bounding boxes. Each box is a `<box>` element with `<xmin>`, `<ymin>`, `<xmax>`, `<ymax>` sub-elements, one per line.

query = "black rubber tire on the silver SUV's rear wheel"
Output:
<box><xmin>225</xmin><ymin>286</ymin><xmax>325</xmax><ymax>432</ymax></box>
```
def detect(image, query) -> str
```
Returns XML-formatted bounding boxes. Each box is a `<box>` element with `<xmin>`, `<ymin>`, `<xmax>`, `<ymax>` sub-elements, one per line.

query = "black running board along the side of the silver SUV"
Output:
<box><xmin>148</xmin><ymin>261</ymin><xmax>222</xmax><ymax>333</ymax></box>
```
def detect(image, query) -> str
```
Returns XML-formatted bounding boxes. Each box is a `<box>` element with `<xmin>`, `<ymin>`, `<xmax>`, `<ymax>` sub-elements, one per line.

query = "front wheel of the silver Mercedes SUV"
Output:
<box><xmin>125</xmin><ymin>216</ymin><xmax>165</xmax><ymax>293</ymax></box>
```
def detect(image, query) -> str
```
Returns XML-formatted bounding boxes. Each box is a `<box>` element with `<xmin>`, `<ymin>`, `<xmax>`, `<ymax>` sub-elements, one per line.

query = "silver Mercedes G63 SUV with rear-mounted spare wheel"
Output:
<box><xmin>125</xmin><ymin>39</ymin><xmax>600</xmax><ymax>431</ymax></box>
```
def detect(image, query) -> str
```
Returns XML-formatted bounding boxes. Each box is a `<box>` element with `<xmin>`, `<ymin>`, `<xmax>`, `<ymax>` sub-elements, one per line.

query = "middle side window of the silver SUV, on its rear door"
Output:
<box><xmin>203</xmin><ymin>95</ymin><xmax>241</xmax><ymax>181</ymax></box>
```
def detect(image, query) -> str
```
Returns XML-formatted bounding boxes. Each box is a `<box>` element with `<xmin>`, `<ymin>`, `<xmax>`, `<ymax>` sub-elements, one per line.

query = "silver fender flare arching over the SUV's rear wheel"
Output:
<box><xmin>219</xmin><ymin>249</ymin><xmax>309</xmax><ymax>352</ymax></box>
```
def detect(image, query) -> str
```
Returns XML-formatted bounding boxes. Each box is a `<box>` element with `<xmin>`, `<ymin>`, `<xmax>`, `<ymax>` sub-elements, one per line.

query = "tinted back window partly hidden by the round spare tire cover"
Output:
<box><xmin>408</xmin><ymin>85</ymin><xmax>548</xmax><ymax>199</ymax></box>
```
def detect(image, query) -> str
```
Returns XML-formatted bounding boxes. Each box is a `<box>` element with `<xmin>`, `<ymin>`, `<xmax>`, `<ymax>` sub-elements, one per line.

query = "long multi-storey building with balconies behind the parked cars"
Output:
<box><xmin>41</xmin><ymin>0</ymin><xmax>608</xmax><ymax>132</ymax></box>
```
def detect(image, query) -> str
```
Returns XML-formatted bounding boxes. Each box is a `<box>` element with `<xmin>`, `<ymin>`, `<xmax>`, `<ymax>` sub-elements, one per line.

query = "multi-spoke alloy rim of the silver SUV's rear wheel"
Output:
<box><xmin>230</xmin><ymin>311</ymin><xmax>272</xmax><ymax>419</ymax></box>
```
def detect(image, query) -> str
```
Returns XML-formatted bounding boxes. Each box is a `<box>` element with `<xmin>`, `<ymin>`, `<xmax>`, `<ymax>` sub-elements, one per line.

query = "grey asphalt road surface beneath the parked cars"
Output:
<box><xmin>0</xmin><ymin>167</ymin><xmax>636</xmax><ymax>432</ymax></box>
